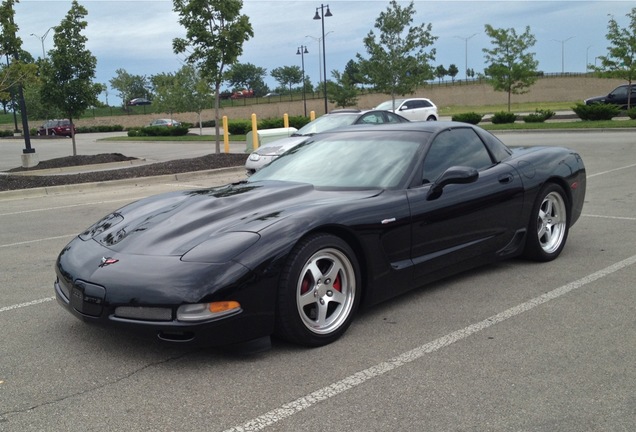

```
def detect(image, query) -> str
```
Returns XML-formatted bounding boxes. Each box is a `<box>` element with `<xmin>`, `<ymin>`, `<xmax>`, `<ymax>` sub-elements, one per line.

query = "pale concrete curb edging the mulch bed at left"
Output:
<box><xmin>0</xmin><ymin>166</ymin><xmax>245</xmax><ymax>199</ymax></box>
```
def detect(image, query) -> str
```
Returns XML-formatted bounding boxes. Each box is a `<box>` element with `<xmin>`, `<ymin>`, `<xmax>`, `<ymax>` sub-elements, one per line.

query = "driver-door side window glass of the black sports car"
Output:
<box><xmin>422</xmin><ymin>128</ymin><xmax>493</xmax><ymax>183</ymax></box>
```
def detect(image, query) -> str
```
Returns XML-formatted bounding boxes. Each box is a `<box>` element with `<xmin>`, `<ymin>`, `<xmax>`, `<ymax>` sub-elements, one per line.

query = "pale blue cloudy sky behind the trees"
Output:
<box><xmin>15</xmin><ymin>0</ymin><xmax>636</xmax><ymax>104</ymax></box>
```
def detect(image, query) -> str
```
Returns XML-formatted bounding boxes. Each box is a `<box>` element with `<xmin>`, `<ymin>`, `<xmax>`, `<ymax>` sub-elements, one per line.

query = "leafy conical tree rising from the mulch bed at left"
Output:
<box><xmin>41</xmin><ymin>0</ymin><xmax>102</xmax><ymax>156</ymax></box>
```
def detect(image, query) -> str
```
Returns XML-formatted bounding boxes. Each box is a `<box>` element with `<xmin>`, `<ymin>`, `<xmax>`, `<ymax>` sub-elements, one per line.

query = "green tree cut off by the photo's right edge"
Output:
<box><xmin>589</xmin><ymin>8</ymin><xmax>636</xmax><ymax>109</ymax></box>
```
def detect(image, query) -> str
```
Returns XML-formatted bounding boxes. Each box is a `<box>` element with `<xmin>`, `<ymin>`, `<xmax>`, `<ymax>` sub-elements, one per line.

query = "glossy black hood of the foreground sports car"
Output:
<box><xmin>80</xmin><ymin>181</ymin><xmax>378</xmax><ymax>256</ymax></box>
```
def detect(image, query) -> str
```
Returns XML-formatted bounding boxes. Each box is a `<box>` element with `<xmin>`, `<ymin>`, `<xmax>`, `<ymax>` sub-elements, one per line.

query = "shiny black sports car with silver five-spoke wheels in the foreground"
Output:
<box><xmin>55</xmin><ymin>122</ymin><xmax>586</xmax><ymax>346</ymax></box>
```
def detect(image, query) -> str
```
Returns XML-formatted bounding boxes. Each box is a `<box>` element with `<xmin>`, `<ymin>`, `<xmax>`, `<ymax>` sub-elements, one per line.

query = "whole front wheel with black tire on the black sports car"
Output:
<box><xmin>276</xmin><ymin>233</ymin><xmax>360</xmax><ymax>347</ymax></box>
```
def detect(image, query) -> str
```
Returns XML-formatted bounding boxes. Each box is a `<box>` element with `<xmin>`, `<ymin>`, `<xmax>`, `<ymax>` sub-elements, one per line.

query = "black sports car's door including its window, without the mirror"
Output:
<box><xmin>408</xmin><ymin>127</ymin><xmax>523</xmax><ymax>279</ymax></box>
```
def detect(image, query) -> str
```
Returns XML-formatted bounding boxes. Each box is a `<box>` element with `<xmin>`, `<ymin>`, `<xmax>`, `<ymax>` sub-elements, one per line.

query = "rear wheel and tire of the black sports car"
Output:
<box><xmin>524</xmin><ymin>183</ymin><xmax>570</xmax><ymax>261</ymax></box>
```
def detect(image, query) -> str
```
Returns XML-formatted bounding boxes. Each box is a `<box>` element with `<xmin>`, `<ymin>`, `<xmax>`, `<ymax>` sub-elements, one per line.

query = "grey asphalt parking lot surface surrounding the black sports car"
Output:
<box><xmin>0</xmin><ymin>131</ymin><xmax>636</xmax><ymax>432</ymax></box>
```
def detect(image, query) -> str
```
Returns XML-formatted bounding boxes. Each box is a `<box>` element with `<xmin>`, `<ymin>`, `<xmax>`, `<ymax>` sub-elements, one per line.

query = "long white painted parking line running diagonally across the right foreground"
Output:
<box><xmin>224</xmin><ymin>255</ymin><xmax>636</xmax><ymax>432</ymax></box>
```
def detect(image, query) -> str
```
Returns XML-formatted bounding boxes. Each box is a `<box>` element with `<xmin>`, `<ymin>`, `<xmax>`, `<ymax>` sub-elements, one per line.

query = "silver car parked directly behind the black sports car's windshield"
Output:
<box><xmin>245</xmin><ymin>109</ymin><xmax>408</xmax><ymax>174</ymax></box>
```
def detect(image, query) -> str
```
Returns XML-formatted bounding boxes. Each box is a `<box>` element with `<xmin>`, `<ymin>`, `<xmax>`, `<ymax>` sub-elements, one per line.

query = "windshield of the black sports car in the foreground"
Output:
<box><xmin>248</xmin><ymin>130</ymin><xmax>425</xmax><ymax>189</ymax></box>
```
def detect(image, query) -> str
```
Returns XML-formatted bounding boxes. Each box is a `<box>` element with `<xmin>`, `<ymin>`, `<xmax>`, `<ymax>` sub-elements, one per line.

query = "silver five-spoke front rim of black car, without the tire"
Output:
<box><xmin>296</xmin><ymin>248</ymin><xmax>356</xmax><ymax>335</ymax></box>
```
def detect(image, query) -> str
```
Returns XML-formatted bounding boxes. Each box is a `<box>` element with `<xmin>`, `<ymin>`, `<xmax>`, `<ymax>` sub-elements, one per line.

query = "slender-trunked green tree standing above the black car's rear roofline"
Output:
<box><xmin>483</xmin><ymin>24</ymin><xmax>539</xmax><ymax>112</ymax></box>
